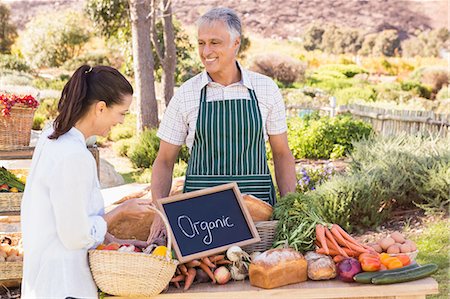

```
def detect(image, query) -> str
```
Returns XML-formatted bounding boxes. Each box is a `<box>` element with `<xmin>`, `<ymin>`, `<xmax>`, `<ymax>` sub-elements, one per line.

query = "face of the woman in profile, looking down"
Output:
<box><xmin>95</xmin><ymin>94</ymin><xmax>133</xmax><ymax>136</ymax></box>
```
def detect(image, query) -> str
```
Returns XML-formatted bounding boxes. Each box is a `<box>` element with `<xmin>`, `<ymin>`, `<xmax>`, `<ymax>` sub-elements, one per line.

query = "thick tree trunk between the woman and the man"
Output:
<box><xmin>129</xmin><ymin>0</ymin><xmax>158</xmax><ymax>132</ymax></box>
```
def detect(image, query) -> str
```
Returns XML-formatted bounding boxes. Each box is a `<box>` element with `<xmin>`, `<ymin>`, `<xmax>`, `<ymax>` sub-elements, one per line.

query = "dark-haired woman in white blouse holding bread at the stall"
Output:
<box><xmin>21</xmin><ymin>65</ymin><xmax>150</xmax><ymax>298</ymax></box>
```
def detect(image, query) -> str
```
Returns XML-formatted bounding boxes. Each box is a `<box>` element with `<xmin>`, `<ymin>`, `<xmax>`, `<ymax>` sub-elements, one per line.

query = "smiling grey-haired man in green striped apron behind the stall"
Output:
<box><xmin>151</xmin><ymin>8</ymin><xmax>296</xmax><ymax>205</ymax></box>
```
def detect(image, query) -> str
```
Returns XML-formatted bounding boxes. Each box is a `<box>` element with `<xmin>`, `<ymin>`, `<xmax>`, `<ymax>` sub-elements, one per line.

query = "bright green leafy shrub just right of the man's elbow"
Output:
<box><xmin>288</xmin><ymin>113</ymin><xmax>372</xmax><ymax>159</ymax></box>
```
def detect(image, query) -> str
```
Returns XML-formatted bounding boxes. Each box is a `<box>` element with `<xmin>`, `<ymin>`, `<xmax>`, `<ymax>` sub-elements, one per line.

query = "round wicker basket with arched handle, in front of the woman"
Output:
<box><xmin>89</xmin><ymin>208</ymin><xmax>178</xmax><ymax>296</ymax></box>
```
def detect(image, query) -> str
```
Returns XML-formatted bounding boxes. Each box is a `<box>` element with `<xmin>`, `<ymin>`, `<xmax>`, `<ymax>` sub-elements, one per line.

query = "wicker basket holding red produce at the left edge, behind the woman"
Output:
<box><xmin>0</xmin><ymin>105</ymin><xmax>35</xmax><ymax>150</ymax></box>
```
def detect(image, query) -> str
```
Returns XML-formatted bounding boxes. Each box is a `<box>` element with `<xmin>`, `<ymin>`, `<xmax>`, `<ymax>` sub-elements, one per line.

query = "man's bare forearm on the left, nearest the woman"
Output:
<box><xmin>151</xmin><ymin>159</ymin><xmax>173</xmax><ymax>200</ymax></box>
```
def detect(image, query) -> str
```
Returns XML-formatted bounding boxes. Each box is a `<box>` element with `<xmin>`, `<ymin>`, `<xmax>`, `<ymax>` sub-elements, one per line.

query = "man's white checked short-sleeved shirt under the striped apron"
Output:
<box><xmin>157</xmin><ymin>64</ymin><xmax>287</xmax><ymax>149</ymax></box>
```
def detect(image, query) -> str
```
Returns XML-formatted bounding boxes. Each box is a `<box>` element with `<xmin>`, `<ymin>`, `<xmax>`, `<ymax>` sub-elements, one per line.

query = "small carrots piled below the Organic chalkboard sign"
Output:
<box><xmin>170</xmin><ymin>254</ymin><xmax>232</xmax><ymax>291</ymax></box>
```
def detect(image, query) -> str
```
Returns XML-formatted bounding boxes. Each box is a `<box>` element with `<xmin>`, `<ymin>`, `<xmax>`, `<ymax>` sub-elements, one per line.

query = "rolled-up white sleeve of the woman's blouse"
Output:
<box><xmin>50</xmin><ymin>153</ymin><xmax>106</xmax><ymax>250</ymax></box>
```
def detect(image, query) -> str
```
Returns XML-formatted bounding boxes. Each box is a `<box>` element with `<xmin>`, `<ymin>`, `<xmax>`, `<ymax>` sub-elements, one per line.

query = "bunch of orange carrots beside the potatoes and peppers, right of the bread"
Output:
<box><xmin>316</xmin><ymin>224</ymin><xmax>373</xmax><ymax>263</ymax></box>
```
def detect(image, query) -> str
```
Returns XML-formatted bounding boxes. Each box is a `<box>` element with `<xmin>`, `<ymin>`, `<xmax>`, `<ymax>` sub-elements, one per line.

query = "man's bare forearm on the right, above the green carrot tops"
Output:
<box><xmin>273</xmin><ymin>153</ymin><xmax>297</xmax><ymax>196</ymax></box>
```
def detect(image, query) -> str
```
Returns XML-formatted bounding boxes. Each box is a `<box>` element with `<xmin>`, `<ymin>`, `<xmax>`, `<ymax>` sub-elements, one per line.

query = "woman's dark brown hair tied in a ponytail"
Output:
<box><xmin>48</xmin><ymin>65</ymin><xmax>133</xmax><ymax>139</ymax></box>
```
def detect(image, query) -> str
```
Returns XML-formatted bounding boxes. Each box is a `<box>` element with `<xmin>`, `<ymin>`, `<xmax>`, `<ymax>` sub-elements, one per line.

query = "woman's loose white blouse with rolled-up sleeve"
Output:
<box><xmin>21</xmin><ymin>128</ymin><xmax>106</xmax><ymax>299</ymax></box>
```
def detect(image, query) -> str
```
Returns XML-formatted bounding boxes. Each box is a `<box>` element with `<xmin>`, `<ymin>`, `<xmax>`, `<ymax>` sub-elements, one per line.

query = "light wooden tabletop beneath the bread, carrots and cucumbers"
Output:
<box><xmin>112</xmin><ymin>277</ymin><xmax>438</xmax><ymax>299</ymax></box>
